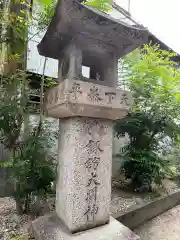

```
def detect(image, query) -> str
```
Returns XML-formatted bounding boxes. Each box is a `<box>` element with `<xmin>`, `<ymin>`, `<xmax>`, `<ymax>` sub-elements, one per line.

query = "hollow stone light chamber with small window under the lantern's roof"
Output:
<box><xmin>58</xmin><ymin>40</ymin><xmax>118</xmax><ymax>87</ymax></box>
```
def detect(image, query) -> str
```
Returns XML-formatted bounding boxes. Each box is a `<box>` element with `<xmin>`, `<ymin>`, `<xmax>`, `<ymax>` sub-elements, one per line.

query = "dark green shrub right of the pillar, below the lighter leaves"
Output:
<box><xmin>115</xmin><ymin>112</ymin><xmax>176</xmax><ymax>189</ymax></box>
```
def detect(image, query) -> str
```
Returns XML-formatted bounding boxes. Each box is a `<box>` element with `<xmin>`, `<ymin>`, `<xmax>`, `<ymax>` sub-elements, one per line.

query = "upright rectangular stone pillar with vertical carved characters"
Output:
<box><xmin>56</xmin><ymin>117</ymin><xmax>113</xmax><ymax>232</ymax></box>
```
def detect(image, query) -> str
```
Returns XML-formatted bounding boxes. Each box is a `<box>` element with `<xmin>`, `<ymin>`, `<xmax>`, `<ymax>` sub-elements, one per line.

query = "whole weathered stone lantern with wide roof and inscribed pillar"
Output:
<box><xmin>32</xmin><ymin>0</ymin><xmax>147</xmax><ymax>240</ymax></box>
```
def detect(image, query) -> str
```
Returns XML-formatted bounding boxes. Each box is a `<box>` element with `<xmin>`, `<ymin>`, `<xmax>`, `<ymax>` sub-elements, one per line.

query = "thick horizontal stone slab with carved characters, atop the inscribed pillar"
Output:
<box><xmin>46</xmin><ymin>79</ymin><xmax>132</xmax><ymax>120</ymax></box>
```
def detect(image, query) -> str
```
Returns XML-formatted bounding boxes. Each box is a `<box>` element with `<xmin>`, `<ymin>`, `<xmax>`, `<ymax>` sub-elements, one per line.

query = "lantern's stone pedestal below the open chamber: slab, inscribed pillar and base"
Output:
<box><xmin>32</xmin><ymin>79</ymin><xmax>138</xmax><ymax>240</ymax></box>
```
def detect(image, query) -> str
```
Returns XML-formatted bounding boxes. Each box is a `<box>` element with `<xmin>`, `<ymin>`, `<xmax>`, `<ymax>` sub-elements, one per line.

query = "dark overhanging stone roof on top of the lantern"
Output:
<box><xmin>38</xmin><ymin>0</ymin><xmax>148</xmax><ymax>59</ymax></box>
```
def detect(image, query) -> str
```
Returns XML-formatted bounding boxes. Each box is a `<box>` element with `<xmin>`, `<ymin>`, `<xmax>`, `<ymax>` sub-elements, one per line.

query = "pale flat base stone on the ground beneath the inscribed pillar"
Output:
<box><xmin>30</xmin><ymin>213</ymin><xmax>139</xmax><ymax>240</ymax></box>
